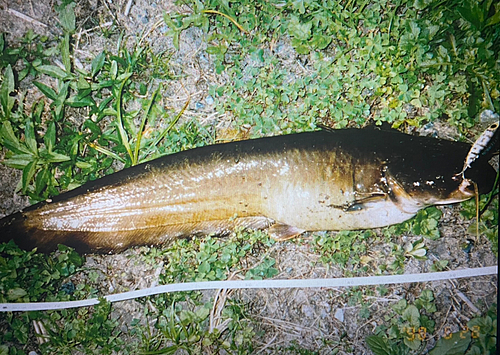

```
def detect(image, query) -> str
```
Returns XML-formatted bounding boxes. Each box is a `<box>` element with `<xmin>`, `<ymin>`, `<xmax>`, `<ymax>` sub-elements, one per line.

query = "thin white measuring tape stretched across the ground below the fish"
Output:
<box><xmin>0</xmin><ymin>265</ymin><xmax>498</xmax><ymax>312</ymax></box>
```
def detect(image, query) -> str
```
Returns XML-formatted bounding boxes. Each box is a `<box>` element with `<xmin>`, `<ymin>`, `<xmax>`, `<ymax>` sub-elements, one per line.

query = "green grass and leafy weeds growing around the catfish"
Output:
<box><xmin>0</xmin><ymin>0</ymin><xmax>500</xmax><ymax>355</ymax></box>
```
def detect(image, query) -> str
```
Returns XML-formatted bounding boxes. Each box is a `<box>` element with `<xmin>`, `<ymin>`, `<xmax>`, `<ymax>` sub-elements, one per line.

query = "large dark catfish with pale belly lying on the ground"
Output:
<box><xmin>0</xmin><ymin>128</ymin><xmax>496</xmax><ymax>252</ymax></box>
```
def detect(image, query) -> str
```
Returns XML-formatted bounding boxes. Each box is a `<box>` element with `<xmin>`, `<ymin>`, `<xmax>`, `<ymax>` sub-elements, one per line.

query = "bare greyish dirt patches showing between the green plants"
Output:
<box><xmin>0</xmin><ymin>0</ymin><xmax>498</xmax><ymax>354</ymax></box>
